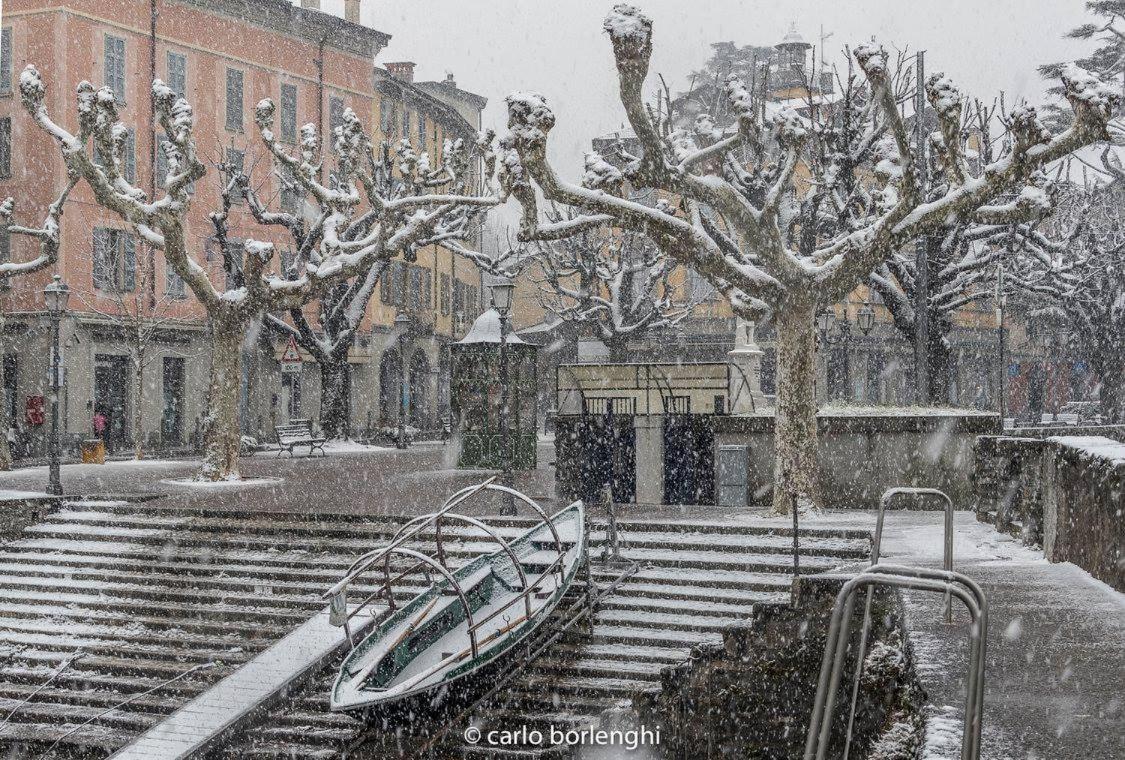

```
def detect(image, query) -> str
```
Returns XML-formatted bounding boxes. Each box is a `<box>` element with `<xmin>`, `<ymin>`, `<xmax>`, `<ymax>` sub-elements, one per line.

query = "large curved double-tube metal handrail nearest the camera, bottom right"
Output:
<box><xmin>803</xmin><ymin>564</ymin><xmax>988</xmax><ymax>760</ymax></box>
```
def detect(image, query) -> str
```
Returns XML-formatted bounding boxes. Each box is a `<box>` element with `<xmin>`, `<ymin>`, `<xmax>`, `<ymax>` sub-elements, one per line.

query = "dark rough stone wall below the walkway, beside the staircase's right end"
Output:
<box><xmin>633</xmin><ymin>577</ymin><xmax>924</xmax><ymax>758</ymax></box>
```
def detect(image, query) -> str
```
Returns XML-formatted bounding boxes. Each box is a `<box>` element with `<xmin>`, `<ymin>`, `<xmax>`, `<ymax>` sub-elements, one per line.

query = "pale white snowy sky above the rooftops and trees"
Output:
<box><xmin>323</xmin><ymin>0</ymin><xmax>1087</xmax><ymax>178</ymax></box>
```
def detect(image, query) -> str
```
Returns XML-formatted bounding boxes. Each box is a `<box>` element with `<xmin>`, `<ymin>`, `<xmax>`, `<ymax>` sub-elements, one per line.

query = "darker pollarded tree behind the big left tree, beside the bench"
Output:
<box><xmin>248</xmin><ymin>128</ymin><xmax>498</xmax><ymax>438</ymax></box>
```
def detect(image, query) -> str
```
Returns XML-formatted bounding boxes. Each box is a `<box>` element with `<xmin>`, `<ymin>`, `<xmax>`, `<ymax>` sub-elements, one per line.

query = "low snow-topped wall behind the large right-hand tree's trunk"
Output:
<box><xmin>714</xmin><ymin>407</ymin><xmax>1000</xmax><ymax>509</ymax></box>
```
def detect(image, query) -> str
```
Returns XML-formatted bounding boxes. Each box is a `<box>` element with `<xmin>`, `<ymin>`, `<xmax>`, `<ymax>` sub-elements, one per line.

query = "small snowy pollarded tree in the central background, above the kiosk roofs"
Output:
<box><xmin>532</xmin><ymin>219</ymin><xmax>692</xmax><ymax>362</ymax></box>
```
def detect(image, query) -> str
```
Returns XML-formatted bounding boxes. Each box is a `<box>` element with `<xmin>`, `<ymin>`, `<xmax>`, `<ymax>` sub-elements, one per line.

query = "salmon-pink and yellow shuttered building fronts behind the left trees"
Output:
<box><xmin>0</xmin><ymin>0</ymin><xmax>484</xmax><ymax>456</ymax></box>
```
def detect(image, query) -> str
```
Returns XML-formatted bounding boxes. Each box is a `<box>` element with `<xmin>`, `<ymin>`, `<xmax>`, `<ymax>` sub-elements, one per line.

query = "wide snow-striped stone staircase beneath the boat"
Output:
<box><xmin>0</xmin><ymin>501</ymin><xmax>867</xmax><ymax>759</ymax></box>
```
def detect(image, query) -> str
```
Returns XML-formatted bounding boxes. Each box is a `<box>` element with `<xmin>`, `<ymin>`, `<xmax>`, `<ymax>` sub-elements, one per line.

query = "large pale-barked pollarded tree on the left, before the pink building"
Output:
<box><xmin>20</xmin><ymin>66</ymin><xmax>497</xmax><ymax>480</ymax></box>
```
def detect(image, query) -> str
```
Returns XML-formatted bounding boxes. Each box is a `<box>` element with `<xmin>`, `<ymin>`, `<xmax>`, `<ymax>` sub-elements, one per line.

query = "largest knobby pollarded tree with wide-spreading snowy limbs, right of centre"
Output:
<box><xmin>500</xmin><ymin>4</ymin><xmax>1116</xmax><ymax>512</ymax></box>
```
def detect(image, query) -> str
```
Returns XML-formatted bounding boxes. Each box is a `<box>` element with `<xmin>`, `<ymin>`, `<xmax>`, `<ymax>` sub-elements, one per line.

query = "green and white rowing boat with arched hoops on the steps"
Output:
<box><xmin>329</xmin><ymin>480</ymin><xmax>586</xmax><ymax>720</ymax></box>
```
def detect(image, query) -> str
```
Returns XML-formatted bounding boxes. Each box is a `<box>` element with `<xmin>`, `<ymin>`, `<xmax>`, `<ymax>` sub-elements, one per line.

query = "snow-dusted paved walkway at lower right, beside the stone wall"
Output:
<box><xmin>883</xmin><ymin>512</ymin><xmax>1125</xmax><ymax>760</ymax></box>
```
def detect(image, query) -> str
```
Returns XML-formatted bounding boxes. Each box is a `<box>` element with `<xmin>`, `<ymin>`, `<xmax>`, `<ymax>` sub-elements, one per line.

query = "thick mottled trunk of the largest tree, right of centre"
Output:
<box><xmin>773</xmin><ymin>301</ymin><xmax>824</xmax><ymax>514</ymax></box>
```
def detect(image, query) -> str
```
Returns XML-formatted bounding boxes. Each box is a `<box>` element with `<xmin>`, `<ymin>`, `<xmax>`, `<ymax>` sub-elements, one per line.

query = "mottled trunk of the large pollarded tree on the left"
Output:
<box><xmin>200</xmin><ymin>316</ymin><xmax>246</xmax><ymax>480</ymax></box>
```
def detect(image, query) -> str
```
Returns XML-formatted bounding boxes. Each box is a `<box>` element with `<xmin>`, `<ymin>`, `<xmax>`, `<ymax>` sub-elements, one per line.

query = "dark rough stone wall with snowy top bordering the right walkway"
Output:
<box><xmin>973</xmin><ymin>436</ymin><xmax>1125</xmax><ymax>591</ymax></box>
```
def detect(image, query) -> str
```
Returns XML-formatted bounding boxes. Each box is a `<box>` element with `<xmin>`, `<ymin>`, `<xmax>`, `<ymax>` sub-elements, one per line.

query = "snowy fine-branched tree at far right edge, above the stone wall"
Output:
<box><xmin>1005</xmin><ymin>182</ymin><xmax>1125</xmax><ymax>424</ymax></box>
